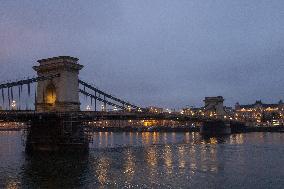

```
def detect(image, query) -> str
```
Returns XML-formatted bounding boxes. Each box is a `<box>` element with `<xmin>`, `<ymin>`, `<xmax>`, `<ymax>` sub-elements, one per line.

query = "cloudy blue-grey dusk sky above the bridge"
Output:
<box><xmin>0</xmin><ymin>0</ymin><xmax>284</xmax><ymax>108</ymax></box>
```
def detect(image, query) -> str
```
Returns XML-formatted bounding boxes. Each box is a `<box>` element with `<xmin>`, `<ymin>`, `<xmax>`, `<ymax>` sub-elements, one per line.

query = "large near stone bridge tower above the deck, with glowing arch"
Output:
<box><xmin>33</xmin><ymin>56</ymin><xmax>83</xmax><ymax>112</ymax></box>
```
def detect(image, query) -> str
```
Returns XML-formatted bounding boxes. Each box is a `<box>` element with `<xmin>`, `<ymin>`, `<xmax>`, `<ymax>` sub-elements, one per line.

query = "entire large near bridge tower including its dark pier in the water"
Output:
<box><xmin>26</xmin><ymin>56</ymin><xmax>88</xmax><ymax>152</ymax></box>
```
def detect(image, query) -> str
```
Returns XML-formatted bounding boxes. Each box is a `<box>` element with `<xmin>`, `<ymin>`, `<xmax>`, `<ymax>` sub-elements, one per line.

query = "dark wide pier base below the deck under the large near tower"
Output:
<box><xmin>26</xmin><ymin>113</ymin><xmax>89</xmax><ymax>152</ymax></box>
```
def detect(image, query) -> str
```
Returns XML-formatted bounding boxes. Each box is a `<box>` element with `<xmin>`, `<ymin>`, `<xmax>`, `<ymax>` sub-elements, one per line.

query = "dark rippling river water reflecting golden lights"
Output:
<box><xmin>0</xmin><ymin>131</ymin><xmax>284</xmax><ymax>189</ymax></box>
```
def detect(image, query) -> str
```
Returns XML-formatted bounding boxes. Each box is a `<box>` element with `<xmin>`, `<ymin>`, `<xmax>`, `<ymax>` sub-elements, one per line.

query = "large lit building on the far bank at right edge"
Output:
<box><xmin>235</xmin><ymin>100</ymin><xmax>284</xmax><ymax>124</ymax></box>
